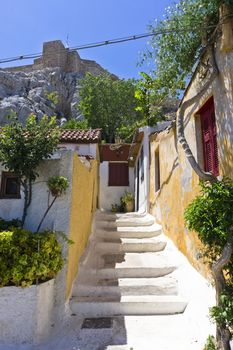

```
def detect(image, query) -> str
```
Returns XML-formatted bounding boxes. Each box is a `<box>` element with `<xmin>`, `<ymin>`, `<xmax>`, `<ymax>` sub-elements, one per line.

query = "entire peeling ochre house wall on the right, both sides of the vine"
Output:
<box><xmin>150</xmin><ymin>39</ymin><xmax>233</xmax><ymax>274</ymax></box>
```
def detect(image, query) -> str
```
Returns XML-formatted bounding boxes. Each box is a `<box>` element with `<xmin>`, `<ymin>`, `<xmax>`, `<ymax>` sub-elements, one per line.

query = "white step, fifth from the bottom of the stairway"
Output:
<box><xmin>95</xmin><ymin>223</ymin><xmax>162</xmax><ymax>238</ymax></box>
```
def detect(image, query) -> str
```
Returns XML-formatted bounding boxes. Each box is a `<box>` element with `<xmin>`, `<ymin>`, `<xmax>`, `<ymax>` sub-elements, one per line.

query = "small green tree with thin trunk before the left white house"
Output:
<box><xmin>0</xmin><ymin>114</ymin><xmax>60</xmax><ymax>225</ymax></box>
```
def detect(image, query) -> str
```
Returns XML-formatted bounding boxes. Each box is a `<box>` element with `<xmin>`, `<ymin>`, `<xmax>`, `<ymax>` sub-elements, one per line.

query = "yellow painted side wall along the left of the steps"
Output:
<box><xmin>66</xmin><ymin>154</ymin><xmax>98</xmax><ymax>298</ymax></box>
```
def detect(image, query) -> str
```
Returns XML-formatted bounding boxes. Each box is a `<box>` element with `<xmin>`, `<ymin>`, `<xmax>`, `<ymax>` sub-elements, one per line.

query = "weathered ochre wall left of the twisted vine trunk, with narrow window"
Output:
<box><xmin>150</xmin><ymin>129</ymin><xmax>206</xmax><ymax>274</ymax></box>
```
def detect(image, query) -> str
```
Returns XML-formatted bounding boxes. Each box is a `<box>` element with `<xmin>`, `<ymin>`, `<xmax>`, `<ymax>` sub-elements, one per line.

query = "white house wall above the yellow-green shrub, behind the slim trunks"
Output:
<box><xmin>0</xmin><ymin>151</ymin><xmax>73</xmax><ymax>233</ymax></box>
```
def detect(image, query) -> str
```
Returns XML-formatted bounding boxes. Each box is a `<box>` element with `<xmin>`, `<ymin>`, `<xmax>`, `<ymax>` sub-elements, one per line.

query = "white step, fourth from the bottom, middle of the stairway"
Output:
<box><xmin>95</xmin><ymin>237</ymin><xmax>167</xmax><ymax>253</ymax></box>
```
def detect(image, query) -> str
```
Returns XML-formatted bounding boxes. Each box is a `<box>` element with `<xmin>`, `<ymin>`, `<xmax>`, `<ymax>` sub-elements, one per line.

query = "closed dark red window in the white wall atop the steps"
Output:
<box><xmin>108</xmin><ymin>162</ymin><xmax>129</xmax><ymax>186</ymax></box>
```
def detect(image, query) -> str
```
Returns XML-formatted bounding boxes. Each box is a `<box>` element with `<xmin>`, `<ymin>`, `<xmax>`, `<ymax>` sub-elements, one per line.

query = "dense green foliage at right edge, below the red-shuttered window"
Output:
<box><xmin>185</xmin><ymin>179</ymin><xmax>233</xmax><ymax>252</ymax></box>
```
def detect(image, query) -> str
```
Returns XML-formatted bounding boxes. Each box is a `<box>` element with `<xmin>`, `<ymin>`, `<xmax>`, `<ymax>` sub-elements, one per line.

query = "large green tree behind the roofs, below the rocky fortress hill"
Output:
<box><xmin>79</xmin><ymin>73</ymin><xmax>143</xmax><ymax>142</ymax></box>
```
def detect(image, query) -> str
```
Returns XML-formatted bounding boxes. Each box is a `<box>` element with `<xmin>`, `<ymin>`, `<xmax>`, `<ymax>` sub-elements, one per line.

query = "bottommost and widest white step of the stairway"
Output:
<box><xmin>71</xmin><ymin>295</ymin><xmax>187</xmax><ymax>317</ymax></box>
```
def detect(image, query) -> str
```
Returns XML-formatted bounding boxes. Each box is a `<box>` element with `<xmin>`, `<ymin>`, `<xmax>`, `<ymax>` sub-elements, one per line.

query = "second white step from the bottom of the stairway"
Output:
<box><xmin>73</xmin><ymin>276</ymin><xmax>178</xmax><ymax>296</ymax></box>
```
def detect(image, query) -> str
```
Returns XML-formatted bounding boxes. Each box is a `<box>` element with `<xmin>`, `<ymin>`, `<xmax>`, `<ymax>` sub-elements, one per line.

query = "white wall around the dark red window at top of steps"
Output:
<box><xmin>99</xmin><ymin>162</ymin><xmax>134</xmax><ymax>210</ymax></box>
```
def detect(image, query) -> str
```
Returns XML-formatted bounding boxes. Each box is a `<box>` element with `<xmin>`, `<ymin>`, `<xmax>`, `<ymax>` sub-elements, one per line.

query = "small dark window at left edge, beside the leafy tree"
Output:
<box><xmin>0</xmin><ymin>171</ymin><xmax>20</xmax><ymax>198</ymax></box>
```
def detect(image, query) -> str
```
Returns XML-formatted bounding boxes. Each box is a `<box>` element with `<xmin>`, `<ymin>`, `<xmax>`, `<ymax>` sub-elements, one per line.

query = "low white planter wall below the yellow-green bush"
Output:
<box><xmin>0</xmin><ymin>280</ymin><xmax>54</xmax><ymax>345</ymax></box>
